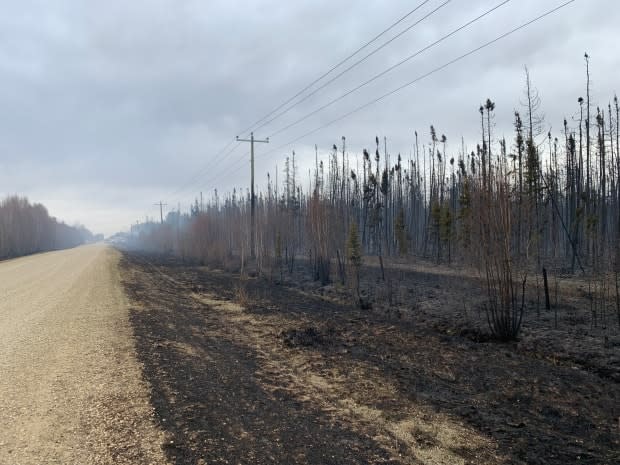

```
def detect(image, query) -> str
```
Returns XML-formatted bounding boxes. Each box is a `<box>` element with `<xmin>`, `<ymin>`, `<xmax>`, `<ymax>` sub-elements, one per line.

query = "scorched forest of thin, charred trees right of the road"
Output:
<box><xmin>136</xmin><ymin>59</ymin><xmax>620</xmax><ymax>340</ymax></box>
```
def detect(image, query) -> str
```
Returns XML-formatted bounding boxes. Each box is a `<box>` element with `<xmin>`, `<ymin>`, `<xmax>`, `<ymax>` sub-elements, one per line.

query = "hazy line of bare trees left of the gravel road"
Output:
<box><xmin>0</xmin><ymin>196</ymin><xmax>94</xmax><ymax>260</ymax></box>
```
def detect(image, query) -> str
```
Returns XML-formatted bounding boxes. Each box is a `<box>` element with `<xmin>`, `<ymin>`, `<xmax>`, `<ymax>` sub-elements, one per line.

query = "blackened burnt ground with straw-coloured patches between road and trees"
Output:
<box><xmin>122</xmin><ymin>253</ymin><xmax>620</xmax><ymax>464</ymax></box>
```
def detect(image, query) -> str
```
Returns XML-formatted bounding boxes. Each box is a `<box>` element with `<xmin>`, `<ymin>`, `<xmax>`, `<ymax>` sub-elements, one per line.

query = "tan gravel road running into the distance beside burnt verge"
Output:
<box><xmin>0</xmin><ymin>245</ymin><xmax>166</xmax><ymax>465</ymax></box>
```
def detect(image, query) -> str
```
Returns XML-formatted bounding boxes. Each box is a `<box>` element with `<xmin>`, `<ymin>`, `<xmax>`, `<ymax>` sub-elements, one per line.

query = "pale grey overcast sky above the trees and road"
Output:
<box><xmin>0</xmin><ymin>0</ymin><xmax>620</xmax><ymax>234</ymax></box>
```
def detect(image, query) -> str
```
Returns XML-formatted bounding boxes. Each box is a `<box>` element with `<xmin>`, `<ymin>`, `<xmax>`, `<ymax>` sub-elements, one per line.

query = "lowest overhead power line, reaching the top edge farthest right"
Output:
<box><xmin>263</xmin><ymin>0</ymin><xmax>576</xmax><ymax>162</ymax></box>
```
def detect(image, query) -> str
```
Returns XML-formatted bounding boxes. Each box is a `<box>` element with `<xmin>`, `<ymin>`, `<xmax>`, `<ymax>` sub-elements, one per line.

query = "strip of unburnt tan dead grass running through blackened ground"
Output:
<box><xmin>176</xmin><ymin>270</ymin><xmax>503</xmax><ymax>465</ymax></box>
